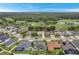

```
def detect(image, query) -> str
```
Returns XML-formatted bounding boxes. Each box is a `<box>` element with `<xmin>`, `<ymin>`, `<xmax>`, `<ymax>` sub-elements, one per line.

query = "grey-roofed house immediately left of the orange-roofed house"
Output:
<box><xmin>33</xmin><ymin>41</ymin><xmax>47</xmax><ymax>50</ymax></box>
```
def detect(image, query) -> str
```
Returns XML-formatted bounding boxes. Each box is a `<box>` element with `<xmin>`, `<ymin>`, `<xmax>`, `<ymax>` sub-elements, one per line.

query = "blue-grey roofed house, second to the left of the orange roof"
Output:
<box><xmin>15</xmin><ymin>41</ymin><xmax>32</xmax><ymax>51</ymax></box>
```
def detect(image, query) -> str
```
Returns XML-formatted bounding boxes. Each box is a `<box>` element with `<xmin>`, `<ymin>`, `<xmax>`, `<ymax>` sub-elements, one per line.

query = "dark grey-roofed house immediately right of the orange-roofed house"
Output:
<box><xmin>61</xmin><ymin>41</ymin><xmax>79</xmax><ymax>54</ymax></box>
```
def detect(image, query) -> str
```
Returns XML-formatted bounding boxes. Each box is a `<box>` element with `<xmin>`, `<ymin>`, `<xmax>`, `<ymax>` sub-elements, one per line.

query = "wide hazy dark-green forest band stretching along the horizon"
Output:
<box><xmin>0</xmin><ymin>12</ymin><xmax>79</xmax><ymax>22</ymax></box>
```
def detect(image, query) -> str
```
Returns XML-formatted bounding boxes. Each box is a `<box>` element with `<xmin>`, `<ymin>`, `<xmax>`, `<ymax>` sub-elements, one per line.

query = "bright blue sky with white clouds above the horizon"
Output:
<box><xmin>0</xmin><ymin>3</ymin><xmax>79</xmax><ymax>12</ymax></box>
